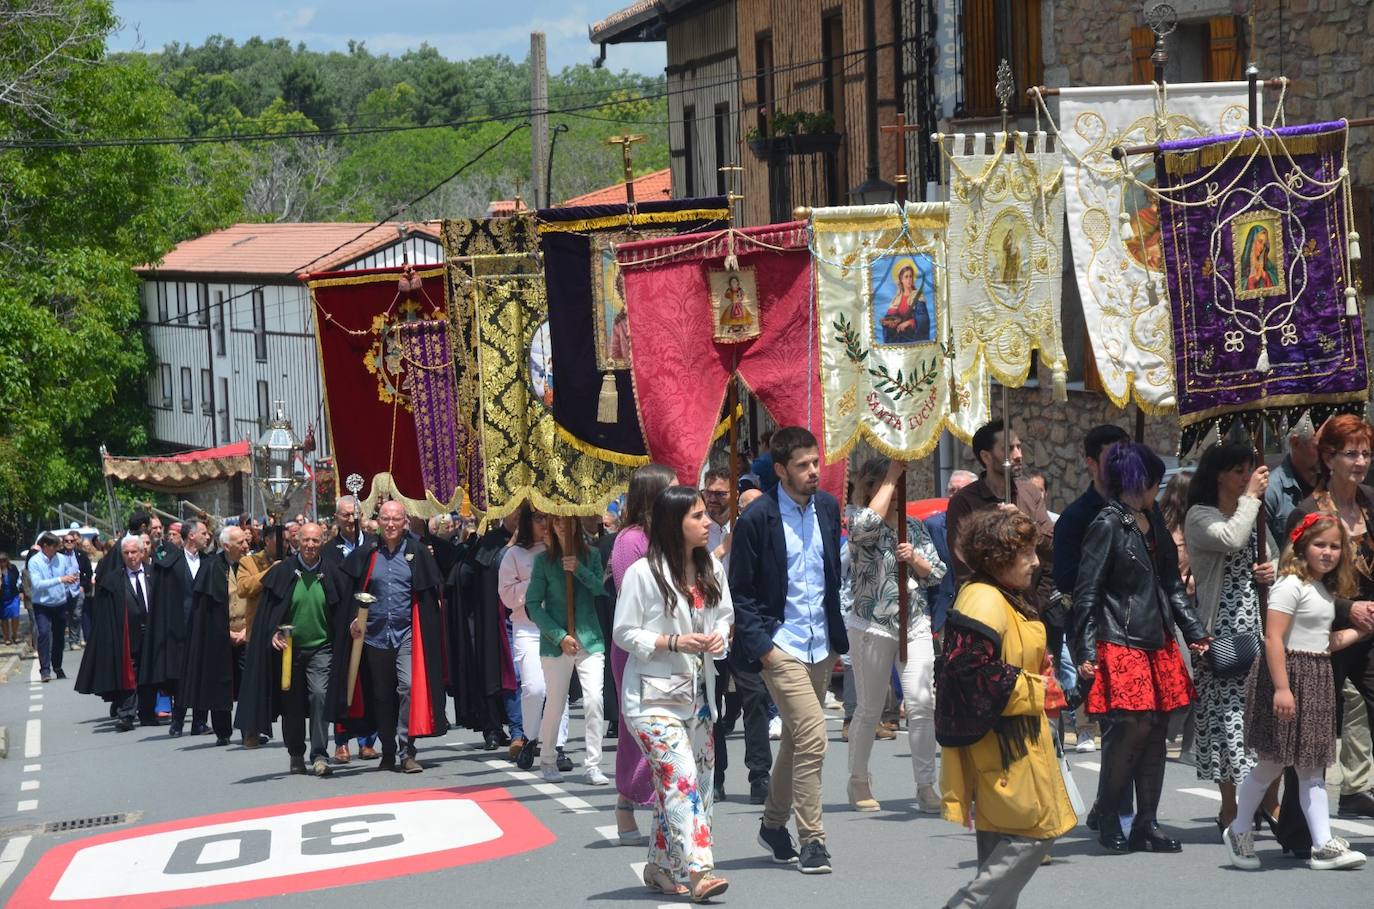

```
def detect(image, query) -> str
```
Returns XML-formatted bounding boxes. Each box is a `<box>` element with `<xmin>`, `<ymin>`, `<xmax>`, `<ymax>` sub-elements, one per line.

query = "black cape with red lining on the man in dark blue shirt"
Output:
<box><xmin>330</xmin><ymin>534</ymin><xmax>448</xmax><ymax>739</ymax></box>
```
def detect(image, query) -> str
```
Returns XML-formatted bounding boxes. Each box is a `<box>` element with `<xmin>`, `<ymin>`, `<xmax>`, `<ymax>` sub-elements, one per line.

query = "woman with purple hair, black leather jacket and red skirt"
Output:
<box><xmin>1073</xmin><ymin>442</ymin><xmax>1206</xmax><ymax>853</ymax></box>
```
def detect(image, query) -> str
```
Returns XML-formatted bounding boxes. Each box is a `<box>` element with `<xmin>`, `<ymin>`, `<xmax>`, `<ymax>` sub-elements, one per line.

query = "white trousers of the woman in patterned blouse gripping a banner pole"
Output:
<box><xmin>849</xmin><ymin>615</ymin><xmax>936</xmax><ymax>787</ymax></box>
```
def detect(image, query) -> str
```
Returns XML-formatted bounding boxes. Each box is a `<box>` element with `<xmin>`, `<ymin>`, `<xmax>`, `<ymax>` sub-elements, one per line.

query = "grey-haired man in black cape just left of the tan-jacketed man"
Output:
<box><xmin>180</xmin><ymin>526</ymin><xmax>249</xmax><ymax>746</ymax></box>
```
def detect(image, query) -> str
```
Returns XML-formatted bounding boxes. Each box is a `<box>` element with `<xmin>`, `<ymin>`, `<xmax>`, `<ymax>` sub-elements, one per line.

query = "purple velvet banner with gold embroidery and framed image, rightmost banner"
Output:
<box><xmin>1160</xmin><ymin>122</ymin><xmax>1369</xmax><ymax>450</ymax></box>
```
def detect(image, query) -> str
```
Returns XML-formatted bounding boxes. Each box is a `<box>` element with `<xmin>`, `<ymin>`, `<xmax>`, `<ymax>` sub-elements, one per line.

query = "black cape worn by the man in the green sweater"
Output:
<box><xmin>234</xmin><ymin>556</ymin><xmax>352</xmax><ymax>736</ymax></box>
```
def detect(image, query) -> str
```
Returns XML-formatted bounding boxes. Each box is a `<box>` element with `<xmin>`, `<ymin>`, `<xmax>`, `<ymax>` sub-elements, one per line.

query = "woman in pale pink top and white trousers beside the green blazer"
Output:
<box><xmin>496</xmin><ymin>503</ymin><xmax>572</xmax><ymax>770</ymax></box>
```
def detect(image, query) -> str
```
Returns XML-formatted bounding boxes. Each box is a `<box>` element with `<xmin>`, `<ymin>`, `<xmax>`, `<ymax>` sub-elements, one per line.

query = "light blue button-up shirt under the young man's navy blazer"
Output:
<box><xmin>774</xmin><ymin>489</ymin><xmax>830</xmax><ymax>663</ymax></box>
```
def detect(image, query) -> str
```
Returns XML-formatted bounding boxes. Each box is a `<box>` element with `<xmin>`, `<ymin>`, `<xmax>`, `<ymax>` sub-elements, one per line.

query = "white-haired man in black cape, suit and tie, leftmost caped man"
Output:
<box><xmin>76</xmin><ymin>537</ymin><xmax>158</xmax><ymax>732</ymax></box>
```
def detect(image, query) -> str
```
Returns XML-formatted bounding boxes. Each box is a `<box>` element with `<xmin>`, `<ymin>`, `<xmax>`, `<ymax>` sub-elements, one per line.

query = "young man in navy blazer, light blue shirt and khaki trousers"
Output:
<box><xmin>730</xmin><ymin>426</ymin><xmax>849</xmax><ymax>875</ymax></box>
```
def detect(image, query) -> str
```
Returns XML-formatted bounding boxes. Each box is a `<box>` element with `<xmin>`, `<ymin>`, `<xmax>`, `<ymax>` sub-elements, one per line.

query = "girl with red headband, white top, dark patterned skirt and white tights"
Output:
<box><xmin>1223</xmin><ymin>512</ymin><xmax>1364</xmax><ymax>871</ymax></box>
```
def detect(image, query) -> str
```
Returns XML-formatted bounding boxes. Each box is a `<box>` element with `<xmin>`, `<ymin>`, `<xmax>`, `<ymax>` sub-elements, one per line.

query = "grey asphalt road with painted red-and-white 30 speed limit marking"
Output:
<box><xmin>0</xmin><ymin>654</ymin><xmax>1374</xmax><ymax>909</ymax></box>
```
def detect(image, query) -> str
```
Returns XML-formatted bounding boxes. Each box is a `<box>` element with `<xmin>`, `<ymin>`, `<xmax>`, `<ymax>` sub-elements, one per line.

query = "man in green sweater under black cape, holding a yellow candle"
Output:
<box><xmin>234</xmin><ymin>523</ymin><xmax>346</xmax><ymax>776</ymax></box>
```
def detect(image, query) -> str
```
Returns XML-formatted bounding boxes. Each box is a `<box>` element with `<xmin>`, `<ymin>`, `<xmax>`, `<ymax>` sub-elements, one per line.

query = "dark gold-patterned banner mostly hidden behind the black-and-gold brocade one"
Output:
<box><xmin>440</xmin><ymin>211</ymin><xmax>536</xmax><ymax>515</ymax></box>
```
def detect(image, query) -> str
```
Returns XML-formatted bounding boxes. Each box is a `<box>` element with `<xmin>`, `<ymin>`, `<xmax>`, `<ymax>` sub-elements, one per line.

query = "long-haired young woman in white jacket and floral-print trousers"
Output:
<box><xmin>611</xmin><ymin>486</ymin><xmax>734</xmax><ymax>902</ymax></box>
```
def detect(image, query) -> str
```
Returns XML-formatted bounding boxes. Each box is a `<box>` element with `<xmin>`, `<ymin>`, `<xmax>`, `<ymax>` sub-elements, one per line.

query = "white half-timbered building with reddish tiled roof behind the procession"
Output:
<box><xmin>135</xmin><ymin>221</ymin><xmax>444</xmax><ymax>457</ymax></box>
